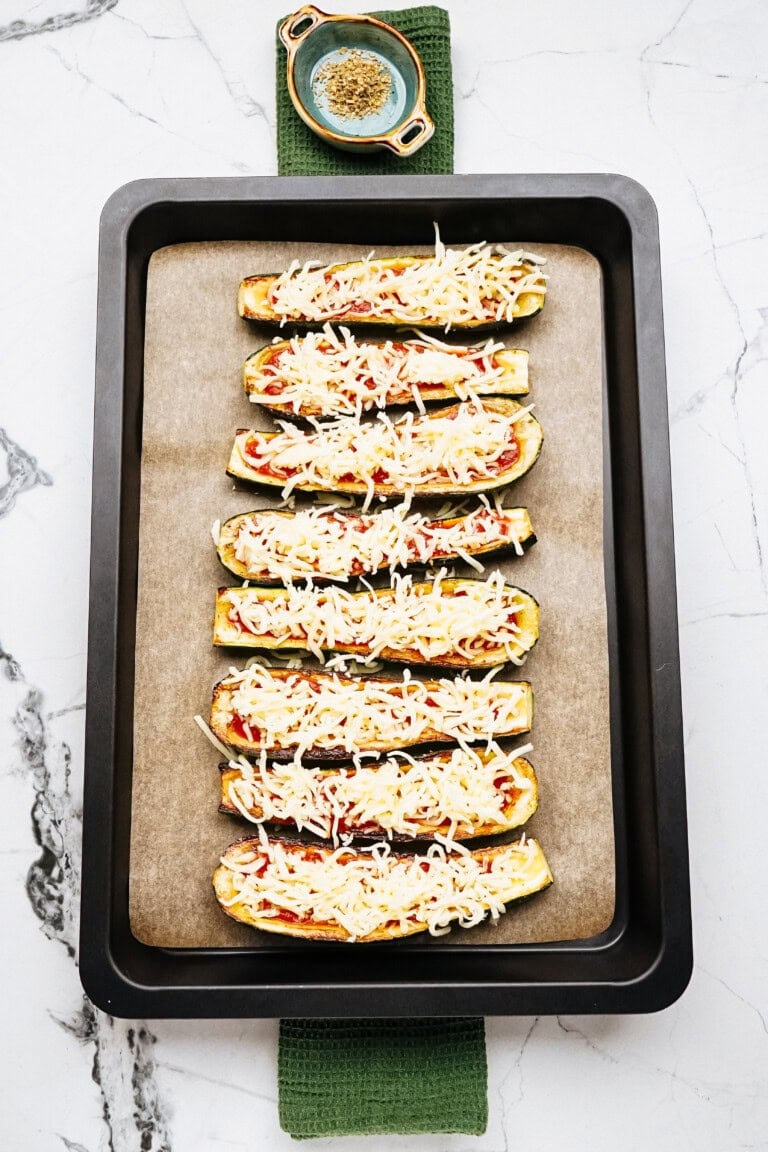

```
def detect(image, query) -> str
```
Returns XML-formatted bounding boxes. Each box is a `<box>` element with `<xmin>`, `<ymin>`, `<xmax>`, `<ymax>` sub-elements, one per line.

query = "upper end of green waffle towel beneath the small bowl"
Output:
<box><xmin>275</xmin><ymin>5</ymin><xmax>454</xmax><ymax>176</ymax></box>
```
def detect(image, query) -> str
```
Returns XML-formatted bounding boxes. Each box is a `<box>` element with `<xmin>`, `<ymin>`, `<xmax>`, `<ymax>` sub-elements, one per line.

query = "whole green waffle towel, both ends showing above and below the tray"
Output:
<box><xmin>276</xmin><ymin>13</ymin><xmax>488</xmax><ymax>1139</ymax></box>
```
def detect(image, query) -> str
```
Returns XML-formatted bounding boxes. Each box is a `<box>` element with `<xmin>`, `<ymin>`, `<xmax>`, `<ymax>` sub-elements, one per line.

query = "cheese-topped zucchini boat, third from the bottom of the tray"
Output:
<box><xmin>211</xmin><ymin>664</ymin><xmax>533</xmax><ymax>760</ymax></box>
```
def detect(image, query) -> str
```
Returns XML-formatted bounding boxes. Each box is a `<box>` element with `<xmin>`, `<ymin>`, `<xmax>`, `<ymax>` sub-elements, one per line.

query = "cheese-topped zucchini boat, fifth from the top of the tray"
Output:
<box><xmin>213</xmin><ymin>571</ymin><xmax>539</xmax><ymax>668</ymax></box>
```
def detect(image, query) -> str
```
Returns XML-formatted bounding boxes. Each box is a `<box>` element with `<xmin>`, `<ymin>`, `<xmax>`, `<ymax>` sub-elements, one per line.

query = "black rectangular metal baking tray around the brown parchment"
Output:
<box><xmin>81</xmin><ymin>175</ymin><xmax>692</xmax><ymax>1017</ymax></box>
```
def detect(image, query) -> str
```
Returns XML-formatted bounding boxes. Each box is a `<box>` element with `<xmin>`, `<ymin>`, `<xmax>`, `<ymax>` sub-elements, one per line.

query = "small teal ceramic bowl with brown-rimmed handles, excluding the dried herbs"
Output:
<box><xmin>280</xmin><ymin>3</ymin><xmax>434</xmax><ymax>156</ymax></box>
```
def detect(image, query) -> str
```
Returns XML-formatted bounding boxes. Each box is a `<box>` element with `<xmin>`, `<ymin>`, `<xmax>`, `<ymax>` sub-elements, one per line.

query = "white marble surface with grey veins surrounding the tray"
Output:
<box><xmin>0</xmin><ymin>0</ymin><xmax>768</xmax><ymax>1152</ymax></box>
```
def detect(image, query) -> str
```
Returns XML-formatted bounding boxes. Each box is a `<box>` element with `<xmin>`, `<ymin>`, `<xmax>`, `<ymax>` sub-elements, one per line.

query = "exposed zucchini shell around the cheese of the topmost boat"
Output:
<box><xmin>237</xmin><ymin>255</ymin><xmax>546</xmax><ymax>332</ymax></box>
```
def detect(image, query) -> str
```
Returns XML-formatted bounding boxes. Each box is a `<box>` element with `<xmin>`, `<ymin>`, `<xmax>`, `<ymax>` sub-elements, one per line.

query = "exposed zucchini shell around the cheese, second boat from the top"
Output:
<box><xmin>243</xmin><ymin>340</ymin><xmax>530</xmax><ymax>420</ymax></box>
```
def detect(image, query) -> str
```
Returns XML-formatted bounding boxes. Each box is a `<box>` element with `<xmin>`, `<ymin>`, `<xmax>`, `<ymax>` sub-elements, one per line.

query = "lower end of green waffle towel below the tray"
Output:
<box><xmin>277</xmin><ymin>1016</ymin><xmax>488</xmax><ymax>1140</ymax></box>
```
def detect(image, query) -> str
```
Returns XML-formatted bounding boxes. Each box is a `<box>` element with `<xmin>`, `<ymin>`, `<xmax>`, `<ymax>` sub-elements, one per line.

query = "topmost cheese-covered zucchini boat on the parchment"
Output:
<box><xmin>237</xmin><ymin>241</ymin><xmax>547</xmax><ymax>332</ymax></box>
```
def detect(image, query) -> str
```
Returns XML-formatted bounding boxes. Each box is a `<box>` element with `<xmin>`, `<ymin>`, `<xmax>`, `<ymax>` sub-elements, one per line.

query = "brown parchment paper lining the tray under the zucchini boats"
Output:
<box><xmin>130</xmin><ymin>237</ymin><xmax>615</xmax><ymax>948</ymax></box>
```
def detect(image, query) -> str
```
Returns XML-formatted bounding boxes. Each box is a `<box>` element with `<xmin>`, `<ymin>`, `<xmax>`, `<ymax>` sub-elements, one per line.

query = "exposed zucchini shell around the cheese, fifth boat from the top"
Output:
<box><xmin>213</xmin><ymin>577</ymin><xmax>539</xmax><ymax>670</ymax></box>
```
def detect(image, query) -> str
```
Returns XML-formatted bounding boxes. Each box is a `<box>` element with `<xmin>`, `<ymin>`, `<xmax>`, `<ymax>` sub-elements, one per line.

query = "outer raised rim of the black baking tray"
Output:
<box><xmin>81</xmin><ymin>174</ymin><xmax>692</xmax><ymax>1016</ymax></box>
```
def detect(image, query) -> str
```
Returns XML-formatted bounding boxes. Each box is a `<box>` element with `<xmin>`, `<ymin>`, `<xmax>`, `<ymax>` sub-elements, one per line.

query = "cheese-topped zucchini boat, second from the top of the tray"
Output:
<box><xmin>243</xmin><ymin>324</ymin><xmax>529</xmax><ymax>419</ymax></box>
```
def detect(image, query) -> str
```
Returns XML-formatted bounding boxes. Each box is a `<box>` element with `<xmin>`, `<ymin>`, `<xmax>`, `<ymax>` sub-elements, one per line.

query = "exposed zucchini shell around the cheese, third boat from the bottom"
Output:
<box><xmin>211</xmin><ymin>668</ymin><xmax>534</xmax><ymax>764</ymax></box>
